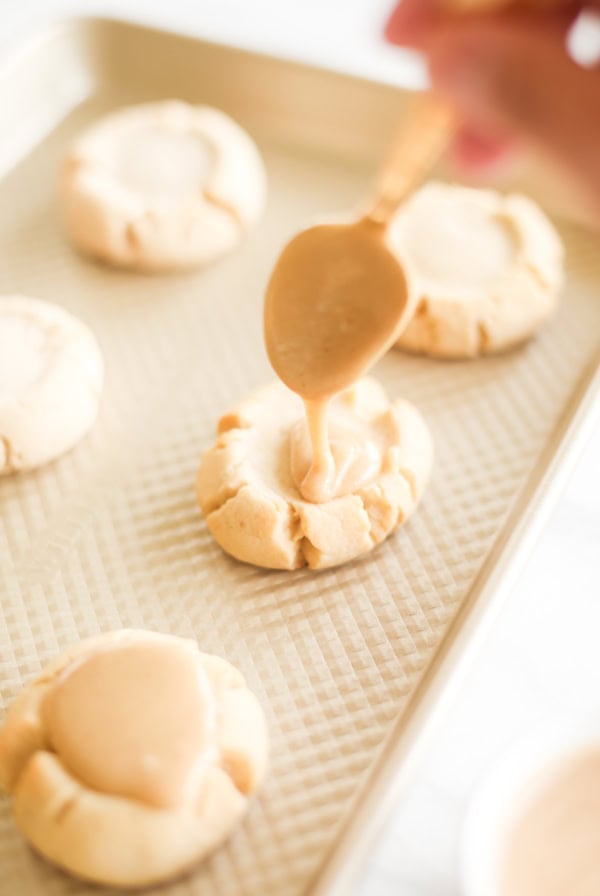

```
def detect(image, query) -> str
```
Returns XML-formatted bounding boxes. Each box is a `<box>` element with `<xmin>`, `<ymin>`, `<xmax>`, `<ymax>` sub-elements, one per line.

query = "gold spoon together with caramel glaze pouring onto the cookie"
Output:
<box><xmin>264</xmin><ymin>97</ymin><xmax>451</xmax><ymax>503</ymax></box>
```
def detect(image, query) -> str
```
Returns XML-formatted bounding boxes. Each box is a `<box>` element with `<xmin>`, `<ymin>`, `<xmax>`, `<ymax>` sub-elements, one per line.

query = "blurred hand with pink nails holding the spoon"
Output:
<box><xmin>386</xmin><ymin>0</ymin><xmax>600</xmax><ymax>202</ymax></box>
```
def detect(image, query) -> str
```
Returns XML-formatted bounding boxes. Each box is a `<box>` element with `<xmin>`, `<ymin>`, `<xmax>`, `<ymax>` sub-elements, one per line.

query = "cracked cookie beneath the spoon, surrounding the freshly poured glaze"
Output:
<box><xmin>196</xmin><ymin>378</ymin><xmax>432</xmax><ymax>569</ymax></box>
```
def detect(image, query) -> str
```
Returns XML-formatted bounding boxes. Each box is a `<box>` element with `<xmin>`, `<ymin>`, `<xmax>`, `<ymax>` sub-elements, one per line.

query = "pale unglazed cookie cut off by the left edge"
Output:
<box><xmin>0</xmin><ymin>296</ymin><xmax>103</xmax><ymax>475</ymax></box>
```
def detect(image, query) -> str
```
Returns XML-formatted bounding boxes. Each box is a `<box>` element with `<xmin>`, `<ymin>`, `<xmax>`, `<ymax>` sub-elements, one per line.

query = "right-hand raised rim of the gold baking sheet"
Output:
<box><xmin>307</xmin><ymin>349</ymin><xmax>600</xmax><ymax>896</ymax></box>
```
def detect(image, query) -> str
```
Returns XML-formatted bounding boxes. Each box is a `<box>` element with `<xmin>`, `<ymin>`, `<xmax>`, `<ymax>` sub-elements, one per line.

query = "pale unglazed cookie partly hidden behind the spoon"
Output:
<box><xmin>389</xmin><ymin>183</ymin><xmax>564</xmax><ymax>358</ymax></box>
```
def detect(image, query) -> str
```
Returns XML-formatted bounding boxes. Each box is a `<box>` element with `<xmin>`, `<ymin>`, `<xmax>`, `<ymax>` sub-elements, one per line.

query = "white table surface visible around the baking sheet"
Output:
<box><xmin>0</xmin><ymin>0</ymin><xmax>600</xmax><ymax>896</ymax></box>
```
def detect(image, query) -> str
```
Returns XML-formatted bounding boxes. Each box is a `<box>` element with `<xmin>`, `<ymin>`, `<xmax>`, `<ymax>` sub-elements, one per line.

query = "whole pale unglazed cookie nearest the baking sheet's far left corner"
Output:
<box><xmin>62</xmin><ymin>100</ymin><xmax>266</xmax><ymax>271</ymax></box>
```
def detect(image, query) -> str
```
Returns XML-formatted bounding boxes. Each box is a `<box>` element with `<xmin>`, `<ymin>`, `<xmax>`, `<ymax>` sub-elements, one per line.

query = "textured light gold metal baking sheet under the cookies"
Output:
<box><xmin>0</xmin><ymin>21</ymin><xmax>600</xmax><ymax>896</ymax></box>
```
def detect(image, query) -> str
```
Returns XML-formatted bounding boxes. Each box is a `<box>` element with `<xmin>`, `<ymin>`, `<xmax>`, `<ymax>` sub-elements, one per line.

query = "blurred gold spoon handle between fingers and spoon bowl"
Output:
<box><xmin>366</xmin><ymin>93</ymin><xmax>455</xmax><ymax>226</ymax></box>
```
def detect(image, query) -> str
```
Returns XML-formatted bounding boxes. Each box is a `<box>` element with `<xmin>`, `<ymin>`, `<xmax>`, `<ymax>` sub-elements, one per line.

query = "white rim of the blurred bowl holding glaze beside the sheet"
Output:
<box><xmin>459</xmin><ymin>718</ymin><xmax>600</xmax><ymax>896</ymax></box>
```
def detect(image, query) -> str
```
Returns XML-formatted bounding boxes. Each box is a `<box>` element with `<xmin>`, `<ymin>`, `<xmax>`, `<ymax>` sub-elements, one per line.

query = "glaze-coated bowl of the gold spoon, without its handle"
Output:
<box><xmin>264</xmin><ymin>218</ymin><xmax>414</xmax><ymax>401</ymax></box>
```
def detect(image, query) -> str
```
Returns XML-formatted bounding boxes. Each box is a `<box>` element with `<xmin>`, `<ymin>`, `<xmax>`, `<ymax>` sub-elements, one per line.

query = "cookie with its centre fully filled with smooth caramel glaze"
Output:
<box><xmin>0</xmin><ymin>630</ymin><xmax>267</xmax><ymax>887</ymax></box>
